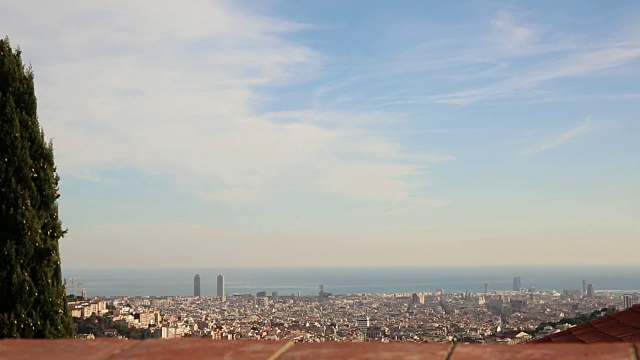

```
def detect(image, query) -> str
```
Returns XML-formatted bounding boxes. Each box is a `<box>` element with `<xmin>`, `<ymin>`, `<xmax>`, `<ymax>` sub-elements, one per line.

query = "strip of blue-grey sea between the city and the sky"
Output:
<box><xmin>63</xmin><ymin>265</ymin><xmax>640</xmax><ymax>297</ymax></box>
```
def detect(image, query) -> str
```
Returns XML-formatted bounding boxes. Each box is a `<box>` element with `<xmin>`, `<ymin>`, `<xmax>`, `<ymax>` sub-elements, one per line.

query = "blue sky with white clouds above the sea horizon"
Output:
<box><xmin>0</xmin><ymin>0</ymin><xmax>640</xmax><ymax>268</ymax></box>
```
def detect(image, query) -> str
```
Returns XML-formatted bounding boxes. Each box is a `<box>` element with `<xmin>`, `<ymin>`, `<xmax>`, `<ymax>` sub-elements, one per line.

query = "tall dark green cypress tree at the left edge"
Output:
<box><xmin>0</xmin><ymin>38</ymin><xmax>74</xmax><ymax>338</ymax></box>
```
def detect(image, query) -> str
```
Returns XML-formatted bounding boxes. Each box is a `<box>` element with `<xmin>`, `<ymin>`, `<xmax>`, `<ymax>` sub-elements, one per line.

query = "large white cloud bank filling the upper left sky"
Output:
<box><xmin>0</xmin><ymin>0</ymin><xmax>451</xmax><ymax>210</ymax></box>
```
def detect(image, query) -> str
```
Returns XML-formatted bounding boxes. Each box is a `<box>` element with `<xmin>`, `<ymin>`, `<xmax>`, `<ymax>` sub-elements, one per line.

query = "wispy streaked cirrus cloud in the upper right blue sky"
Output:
<box><xmin>318</xmin><ymin>10</ymin><xmax>640</xmax><ymax>108</ymax></box>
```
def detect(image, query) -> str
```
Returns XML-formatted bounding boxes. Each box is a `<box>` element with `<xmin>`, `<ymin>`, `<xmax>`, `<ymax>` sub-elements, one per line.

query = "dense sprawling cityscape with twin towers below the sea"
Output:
<box><xmin>69</xmin><ymin>274</ymin><xmax>638</xmax><ymax>344</ymax></box>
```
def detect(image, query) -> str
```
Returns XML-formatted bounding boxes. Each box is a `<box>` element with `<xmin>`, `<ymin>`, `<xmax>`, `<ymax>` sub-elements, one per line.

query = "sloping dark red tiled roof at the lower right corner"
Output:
<box><xmin>531</xmin><ymin>305</ymin><xmax>640</xmax><ymax>344</ymax></box>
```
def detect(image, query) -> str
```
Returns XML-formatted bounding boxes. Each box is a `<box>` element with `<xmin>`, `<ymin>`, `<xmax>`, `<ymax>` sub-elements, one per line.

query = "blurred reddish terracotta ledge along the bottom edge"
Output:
<box><xmin>0</xmin><ymin>339</ymin><xmax>640</xmax><ymax>360</ymax></box>
